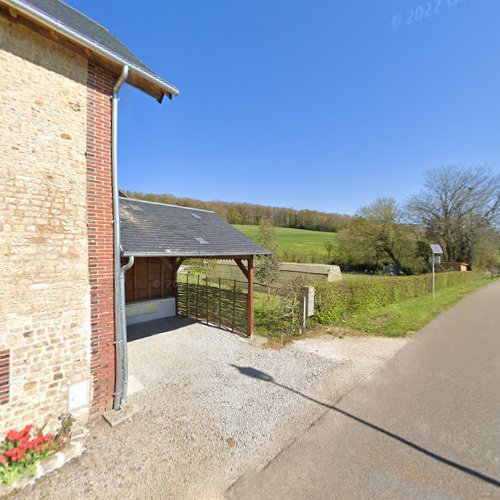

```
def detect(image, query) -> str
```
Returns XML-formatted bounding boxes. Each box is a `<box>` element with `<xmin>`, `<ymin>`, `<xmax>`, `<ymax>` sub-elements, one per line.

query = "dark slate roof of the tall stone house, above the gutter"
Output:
<box><xmin>9</xmin><ymin>0</ymin><xmax>178</xmax><ymax>98</ymax></box>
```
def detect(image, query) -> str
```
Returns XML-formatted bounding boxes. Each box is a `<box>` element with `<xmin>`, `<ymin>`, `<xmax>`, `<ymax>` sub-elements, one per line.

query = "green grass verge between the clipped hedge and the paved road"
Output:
<box><xmin>339</xmin><ymin>277</ymin><xmax>492</xmax><ymax>337</ymax></box>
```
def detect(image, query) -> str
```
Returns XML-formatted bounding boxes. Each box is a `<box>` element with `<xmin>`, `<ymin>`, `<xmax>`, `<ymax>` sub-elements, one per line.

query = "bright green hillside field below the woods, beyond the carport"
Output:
<box><xmin>234</xmin><ymin>224</ymin><xmax>337</xmax><ymax>263</ymax></box>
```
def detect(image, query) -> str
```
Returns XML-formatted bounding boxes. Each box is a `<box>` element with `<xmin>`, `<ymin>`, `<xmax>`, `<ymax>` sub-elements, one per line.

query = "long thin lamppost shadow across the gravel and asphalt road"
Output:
<box><xmin>230</xmin><ymin>364</ymin><xmax>500</xmax><ymax>487</ymax></box>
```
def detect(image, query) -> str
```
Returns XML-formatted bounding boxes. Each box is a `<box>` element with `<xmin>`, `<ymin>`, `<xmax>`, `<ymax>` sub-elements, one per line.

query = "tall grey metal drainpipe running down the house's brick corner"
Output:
<box><xmin>111</xmin><ymin>65</ymin><xmax>133</xmax><ymax>410</ymax></box>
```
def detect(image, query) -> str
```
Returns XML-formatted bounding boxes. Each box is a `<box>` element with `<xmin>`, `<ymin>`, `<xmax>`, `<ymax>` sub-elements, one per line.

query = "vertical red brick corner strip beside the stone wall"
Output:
<box><xmin>86</xmin><ymin>61</ymin><xmax>115</xmax><ymax>415</ymax></box>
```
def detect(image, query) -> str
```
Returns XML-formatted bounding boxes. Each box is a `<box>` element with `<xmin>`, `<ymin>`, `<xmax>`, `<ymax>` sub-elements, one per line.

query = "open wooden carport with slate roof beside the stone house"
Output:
<box><xmin>120</xmin><ymin>197</ymin><xmax>270</xmax><ymax>335</ymax></box>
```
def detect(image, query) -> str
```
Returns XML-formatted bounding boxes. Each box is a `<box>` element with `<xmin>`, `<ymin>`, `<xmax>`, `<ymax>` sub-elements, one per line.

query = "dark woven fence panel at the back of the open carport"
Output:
<box><xmin>177</xmin><ymin>274</ymin><xmax>248</xmax><ymax>335</ymax></box>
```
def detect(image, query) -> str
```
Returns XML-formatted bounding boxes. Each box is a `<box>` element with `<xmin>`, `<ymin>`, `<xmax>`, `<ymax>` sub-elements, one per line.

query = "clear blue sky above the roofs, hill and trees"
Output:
<box><xmin>69</xmin><ymin>0</ymin><xmax>500</xmax><ymax>213</ymax></box>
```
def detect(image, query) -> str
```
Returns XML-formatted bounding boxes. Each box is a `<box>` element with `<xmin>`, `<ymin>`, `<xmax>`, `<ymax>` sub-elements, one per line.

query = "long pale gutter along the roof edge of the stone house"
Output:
<box><xmin>1</xmin><ymin>0</ymin><xmax>179</xmax><ymax>96</ymax></box>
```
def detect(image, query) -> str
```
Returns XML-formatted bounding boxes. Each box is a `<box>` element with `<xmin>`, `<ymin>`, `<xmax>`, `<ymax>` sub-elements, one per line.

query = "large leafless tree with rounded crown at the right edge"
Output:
<box><xmin>407</xmin><ymin>165</ymin><xmax>500</xmax><ymax>262</ymax></box>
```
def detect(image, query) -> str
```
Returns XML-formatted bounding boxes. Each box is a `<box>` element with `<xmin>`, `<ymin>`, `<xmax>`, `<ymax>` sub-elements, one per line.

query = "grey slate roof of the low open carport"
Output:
<box><xmin>120</xmin><ymin>198</ymin><xmax>270</xmax><ymax>257</ymax></box>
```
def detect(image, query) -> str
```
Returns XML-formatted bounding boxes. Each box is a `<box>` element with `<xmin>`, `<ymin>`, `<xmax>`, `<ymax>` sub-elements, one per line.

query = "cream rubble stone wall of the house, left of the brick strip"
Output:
<box><xmin>0</xmin><ymin>17</ymin><xmax>90</xmax><ymax>432</ymax></box>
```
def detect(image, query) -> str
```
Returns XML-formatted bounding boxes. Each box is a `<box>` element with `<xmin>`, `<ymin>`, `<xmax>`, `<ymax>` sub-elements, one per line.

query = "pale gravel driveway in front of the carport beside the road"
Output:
<box><xmin>20</xmin><ymin>320</ymin><xmax>407</xmax><ymax>499</ymax></box>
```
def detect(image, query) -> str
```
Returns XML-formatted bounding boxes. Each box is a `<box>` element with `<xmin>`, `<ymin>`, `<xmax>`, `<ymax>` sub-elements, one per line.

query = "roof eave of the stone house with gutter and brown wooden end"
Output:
<box><xmin>1</xmin><ymin>0</ymin><xmax>179</xmax><ymax>102</ymax></box>
